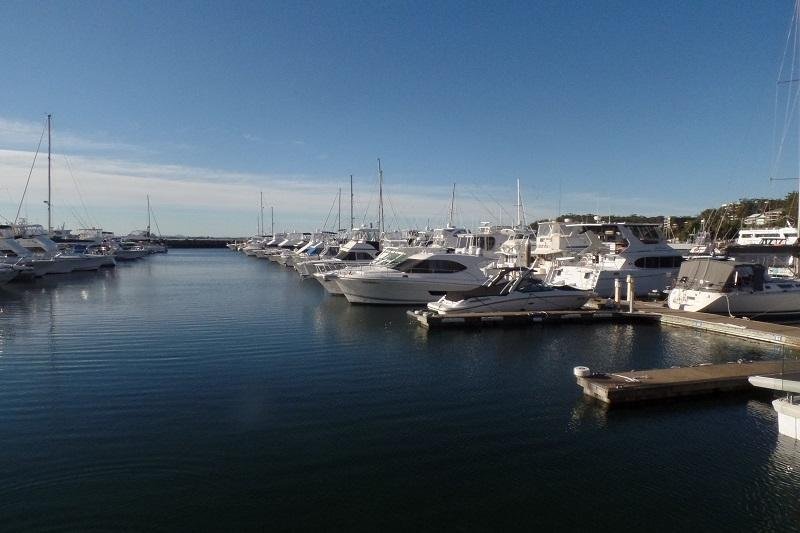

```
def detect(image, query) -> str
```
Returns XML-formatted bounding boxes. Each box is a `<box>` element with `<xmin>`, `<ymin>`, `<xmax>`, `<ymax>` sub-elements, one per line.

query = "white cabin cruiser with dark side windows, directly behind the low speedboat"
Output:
<box><xmin>337</xmin><ymin>251</ymin><xmax>492</xmax><ymax>305</ymax></box>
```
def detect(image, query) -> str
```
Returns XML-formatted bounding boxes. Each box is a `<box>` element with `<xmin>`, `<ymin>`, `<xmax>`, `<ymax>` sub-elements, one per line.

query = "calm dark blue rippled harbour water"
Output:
<box><xmin>0</xmin><ymin>250</ymin><xmax>800</xmax><ymax>531</ymax></box>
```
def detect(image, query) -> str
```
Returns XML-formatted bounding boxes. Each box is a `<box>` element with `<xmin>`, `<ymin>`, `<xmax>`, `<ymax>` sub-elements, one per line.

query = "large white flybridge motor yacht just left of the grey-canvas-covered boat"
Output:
<box><xmin>546</xmin><ymin>222</ymin><xmax>683</xmax><ymax>298</ymax></box>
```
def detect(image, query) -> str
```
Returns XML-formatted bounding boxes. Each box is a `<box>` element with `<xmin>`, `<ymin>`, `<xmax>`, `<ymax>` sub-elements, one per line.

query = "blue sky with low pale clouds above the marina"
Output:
<box><xmin>0</xmin><ymin>0</ymin><xmax>793</xmax><ymax>235</ymax></box>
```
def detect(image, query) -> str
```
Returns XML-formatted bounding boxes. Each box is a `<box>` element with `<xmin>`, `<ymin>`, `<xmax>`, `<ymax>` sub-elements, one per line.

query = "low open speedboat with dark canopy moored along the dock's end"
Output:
<box><xmin>428</xmin><ymin>268</ymin><xmax>594</xmax><ymax>315</ymax></box>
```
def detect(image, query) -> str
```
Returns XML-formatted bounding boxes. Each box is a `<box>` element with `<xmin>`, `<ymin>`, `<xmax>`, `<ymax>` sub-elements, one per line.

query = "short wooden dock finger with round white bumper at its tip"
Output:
<box><xmin>576</xmin><ymin>360</ymin><xmax>800</xmax><ymax>404</ymax></box>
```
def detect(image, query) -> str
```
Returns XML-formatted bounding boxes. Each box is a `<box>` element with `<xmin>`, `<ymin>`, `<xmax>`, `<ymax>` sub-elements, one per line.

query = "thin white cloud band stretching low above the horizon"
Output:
<box><xmin>0</xmin><ymin>150</ymin><xmax>524</xmax><ymax>235</ymax></box>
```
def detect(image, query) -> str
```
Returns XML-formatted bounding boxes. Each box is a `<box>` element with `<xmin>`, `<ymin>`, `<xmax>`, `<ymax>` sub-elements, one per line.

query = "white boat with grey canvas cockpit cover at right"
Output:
<box><xmin>667</xmin><ymin>259</ymin><xmax>800</xmax><ymax>318</ymax></box>
